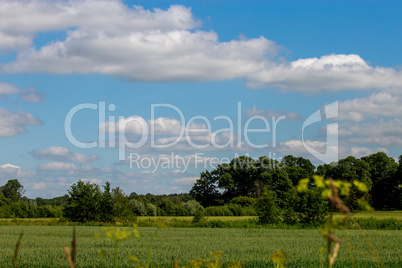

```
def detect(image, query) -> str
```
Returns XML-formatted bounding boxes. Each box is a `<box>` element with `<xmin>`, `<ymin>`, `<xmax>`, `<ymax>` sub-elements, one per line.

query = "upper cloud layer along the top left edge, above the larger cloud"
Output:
<box><xmin>0</xmin><ymin>0</ymin><xmax>199</xmax><ymax>51</ymax></box>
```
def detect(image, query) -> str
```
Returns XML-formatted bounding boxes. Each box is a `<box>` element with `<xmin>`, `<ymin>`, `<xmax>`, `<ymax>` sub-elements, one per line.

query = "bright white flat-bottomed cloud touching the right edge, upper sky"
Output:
<box><xmin>249</xmin><ymin>54</ymin><xmax>402</xmax><ymax>93</ymax></box>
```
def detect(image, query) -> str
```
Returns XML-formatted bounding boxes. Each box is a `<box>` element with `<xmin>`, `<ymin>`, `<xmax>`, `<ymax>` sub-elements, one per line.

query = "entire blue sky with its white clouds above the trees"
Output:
<box><xmin>0</xmin><ymin>1</ymin><xmax>402</xmax><ymax>197</ymax></box>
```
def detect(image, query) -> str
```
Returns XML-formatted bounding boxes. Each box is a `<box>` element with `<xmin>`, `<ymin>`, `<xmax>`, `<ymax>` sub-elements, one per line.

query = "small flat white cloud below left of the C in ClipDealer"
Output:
<box><xmin>31</xmin><ymin>146</ymin><xmax>99</xmax><ymax>163</ymax></box>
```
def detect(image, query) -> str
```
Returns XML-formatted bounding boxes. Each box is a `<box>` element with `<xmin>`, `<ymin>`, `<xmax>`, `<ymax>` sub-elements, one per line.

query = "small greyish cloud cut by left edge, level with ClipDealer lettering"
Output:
<box><xmin>0</xmin><ymin>107</ymin><xmax>42</xmax><ymax>137</ymax></box>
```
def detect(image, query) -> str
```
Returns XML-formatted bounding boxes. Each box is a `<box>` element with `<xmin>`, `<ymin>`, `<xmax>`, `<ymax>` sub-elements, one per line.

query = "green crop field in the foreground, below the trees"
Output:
<box><xmin>0</xmin><ymin>226</ymin><xmax>402</xmax><ymax>267</ymax></box>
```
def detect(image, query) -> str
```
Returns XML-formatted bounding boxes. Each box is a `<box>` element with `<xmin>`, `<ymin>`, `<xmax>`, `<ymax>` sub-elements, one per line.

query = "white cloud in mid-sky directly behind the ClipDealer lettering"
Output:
<box><xmin>99</xmin><ymin>116</ymin><xmax>251</xmax><ymax>152</ymax></box>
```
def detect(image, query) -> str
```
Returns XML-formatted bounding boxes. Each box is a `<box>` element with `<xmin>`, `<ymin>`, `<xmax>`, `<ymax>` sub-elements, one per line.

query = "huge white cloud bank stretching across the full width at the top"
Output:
<box><xmin>0</xmin><ymin>0</ymin><xmax>402</xmax><ymax>93</ymax></box>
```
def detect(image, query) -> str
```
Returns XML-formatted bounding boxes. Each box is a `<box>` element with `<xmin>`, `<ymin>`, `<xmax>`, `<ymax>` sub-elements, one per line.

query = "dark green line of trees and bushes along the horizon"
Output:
<box><xmin>0</xmin><ymin>152</ymin><xmax>402</xmax><ymax>224</ymax></box>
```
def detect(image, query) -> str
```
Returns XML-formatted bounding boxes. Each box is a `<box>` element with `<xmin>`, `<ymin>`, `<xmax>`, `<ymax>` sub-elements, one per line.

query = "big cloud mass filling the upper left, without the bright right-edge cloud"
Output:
<box><xmin>0</xmin><ymin>1</ymin><xmax>277</xmax><ymax>81</ymax></box>
